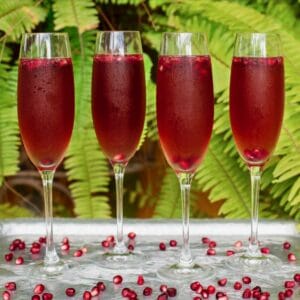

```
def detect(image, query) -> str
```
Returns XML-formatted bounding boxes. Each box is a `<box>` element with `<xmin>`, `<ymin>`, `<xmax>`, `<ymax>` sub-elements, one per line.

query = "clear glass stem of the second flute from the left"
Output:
<box><xmin>113</xmin><ymin>163</ymin><xmax>127</xmax><ymax>254</ymax></box>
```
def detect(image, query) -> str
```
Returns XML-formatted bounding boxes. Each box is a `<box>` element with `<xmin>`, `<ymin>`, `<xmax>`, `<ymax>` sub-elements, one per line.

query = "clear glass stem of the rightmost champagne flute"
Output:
<box><xmin>248</xmin><ymin>166</ymin><xmax>262</xmax><ymax>256</ymax></box>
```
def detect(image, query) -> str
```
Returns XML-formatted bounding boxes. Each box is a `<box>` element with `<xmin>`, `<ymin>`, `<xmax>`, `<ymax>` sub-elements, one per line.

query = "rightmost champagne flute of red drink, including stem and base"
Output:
<box><xmin>228</xmin><ymin>33</ymin><xmax>284</xmax><ymax>270</ymax></box>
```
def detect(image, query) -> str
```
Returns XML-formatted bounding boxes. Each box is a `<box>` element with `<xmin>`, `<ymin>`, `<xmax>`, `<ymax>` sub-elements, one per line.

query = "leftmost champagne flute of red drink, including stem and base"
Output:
<box><xmin>18</xmin><ymin>33</ymin><xmax>74</xmax><ymax>277</ymax></box>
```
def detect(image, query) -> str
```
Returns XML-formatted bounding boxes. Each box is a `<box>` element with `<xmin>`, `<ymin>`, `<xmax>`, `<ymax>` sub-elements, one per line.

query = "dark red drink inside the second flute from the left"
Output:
<box><xmin>92</xmin><ymin>54</ymin><xmax>146</xmax><ymax>163</ymax></box>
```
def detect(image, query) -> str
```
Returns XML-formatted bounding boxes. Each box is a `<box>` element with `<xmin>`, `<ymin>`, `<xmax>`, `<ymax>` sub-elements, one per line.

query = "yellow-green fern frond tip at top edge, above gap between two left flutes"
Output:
<box><xmin>53</xmin><ymin>0</ymin><xmax>99</xmax><ymax>34</ymax></box>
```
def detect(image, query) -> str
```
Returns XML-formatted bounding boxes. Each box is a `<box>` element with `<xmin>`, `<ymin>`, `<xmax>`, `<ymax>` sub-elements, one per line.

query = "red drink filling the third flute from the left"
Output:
<box><xmin>157</xmin><ymin>56</ymin><xmax>214</xmax><ymax>172</ymax></box>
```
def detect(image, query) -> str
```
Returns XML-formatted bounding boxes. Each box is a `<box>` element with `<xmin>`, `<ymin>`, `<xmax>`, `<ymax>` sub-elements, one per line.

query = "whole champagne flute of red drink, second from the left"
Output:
<box><xmin>92</xmin><ymin>31</ymin><xmax>146</xmax><ymax>269</ymax></box>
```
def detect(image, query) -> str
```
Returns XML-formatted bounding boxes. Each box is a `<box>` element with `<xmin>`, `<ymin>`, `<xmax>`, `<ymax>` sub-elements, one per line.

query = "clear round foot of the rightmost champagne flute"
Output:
<box><xmin>225</xmin><ymin>252</ymin><xmax>282</xmax><ymax>272</ymax></box>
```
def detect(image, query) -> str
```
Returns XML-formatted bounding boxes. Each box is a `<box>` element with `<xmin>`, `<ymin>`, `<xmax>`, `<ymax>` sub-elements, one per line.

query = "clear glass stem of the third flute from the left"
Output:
<box><xmin>178</xmin><ymin>173</ymin><xmax>193</xmax><ymax>267</ymax></box>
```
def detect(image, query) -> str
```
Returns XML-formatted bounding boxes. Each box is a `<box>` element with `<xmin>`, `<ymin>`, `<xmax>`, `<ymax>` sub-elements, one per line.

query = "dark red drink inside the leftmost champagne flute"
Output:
<box><xmin>18</xmin><ymin>58</ymin><xmax>74</xmax><ymax>170</ymax></box>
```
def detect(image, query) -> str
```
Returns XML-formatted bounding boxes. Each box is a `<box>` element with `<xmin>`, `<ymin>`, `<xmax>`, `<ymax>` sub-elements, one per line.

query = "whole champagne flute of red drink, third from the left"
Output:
<box><xmin>156</xmin><ymin>33</ymin><xmax>214</xmax><ymax>280</ymax></box>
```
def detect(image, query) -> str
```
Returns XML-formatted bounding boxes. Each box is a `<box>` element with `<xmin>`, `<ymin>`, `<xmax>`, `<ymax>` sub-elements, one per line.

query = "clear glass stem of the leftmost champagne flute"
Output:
<box><xmin>40</xmin><ymin>171</ymin><xmax>59</xmax><ymax>266</ymax></box>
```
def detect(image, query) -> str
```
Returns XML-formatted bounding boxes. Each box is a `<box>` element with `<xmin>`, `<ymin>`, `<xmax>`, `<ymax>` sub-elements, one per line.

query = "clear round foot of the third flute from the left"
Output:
<box><xmin>157</xmin><ymin>263</ymin><xmax>215</xmax><ymax>282</ymax></box>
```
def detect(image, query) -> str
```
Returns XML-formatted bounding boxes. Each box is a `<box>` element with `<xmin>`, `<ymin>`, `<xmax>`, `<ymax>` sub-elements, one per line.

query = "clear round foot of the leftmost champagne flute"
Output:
<box><xmin>28</xmin><ymin>259</ymin><xmax>79</xmax><ymax>280</ymax></box>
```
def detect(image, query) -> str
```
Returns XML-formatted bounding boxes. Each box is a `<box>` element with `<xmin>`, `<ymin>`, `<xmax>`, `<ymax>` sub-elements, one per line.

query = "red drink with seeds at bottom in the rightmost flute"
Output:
<box><xmin>230</xmin><ymin>57</ymin><xmax>284</xmax><ymax>166</ymax></box>
